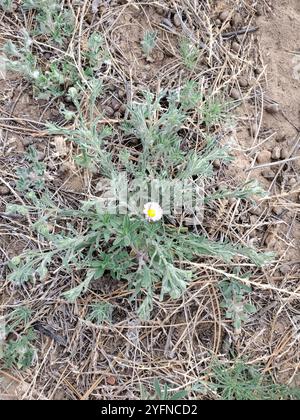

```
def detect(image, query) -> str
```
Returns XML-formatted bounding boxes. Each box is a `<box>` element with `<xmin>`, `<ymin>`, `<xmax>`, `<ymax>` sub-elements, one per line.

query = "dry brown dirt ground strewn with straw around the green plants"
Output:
<box><xmin>0</xmin><ymin>0</ymin><xmax>300</xmax><ymax>399</ymax></box>
